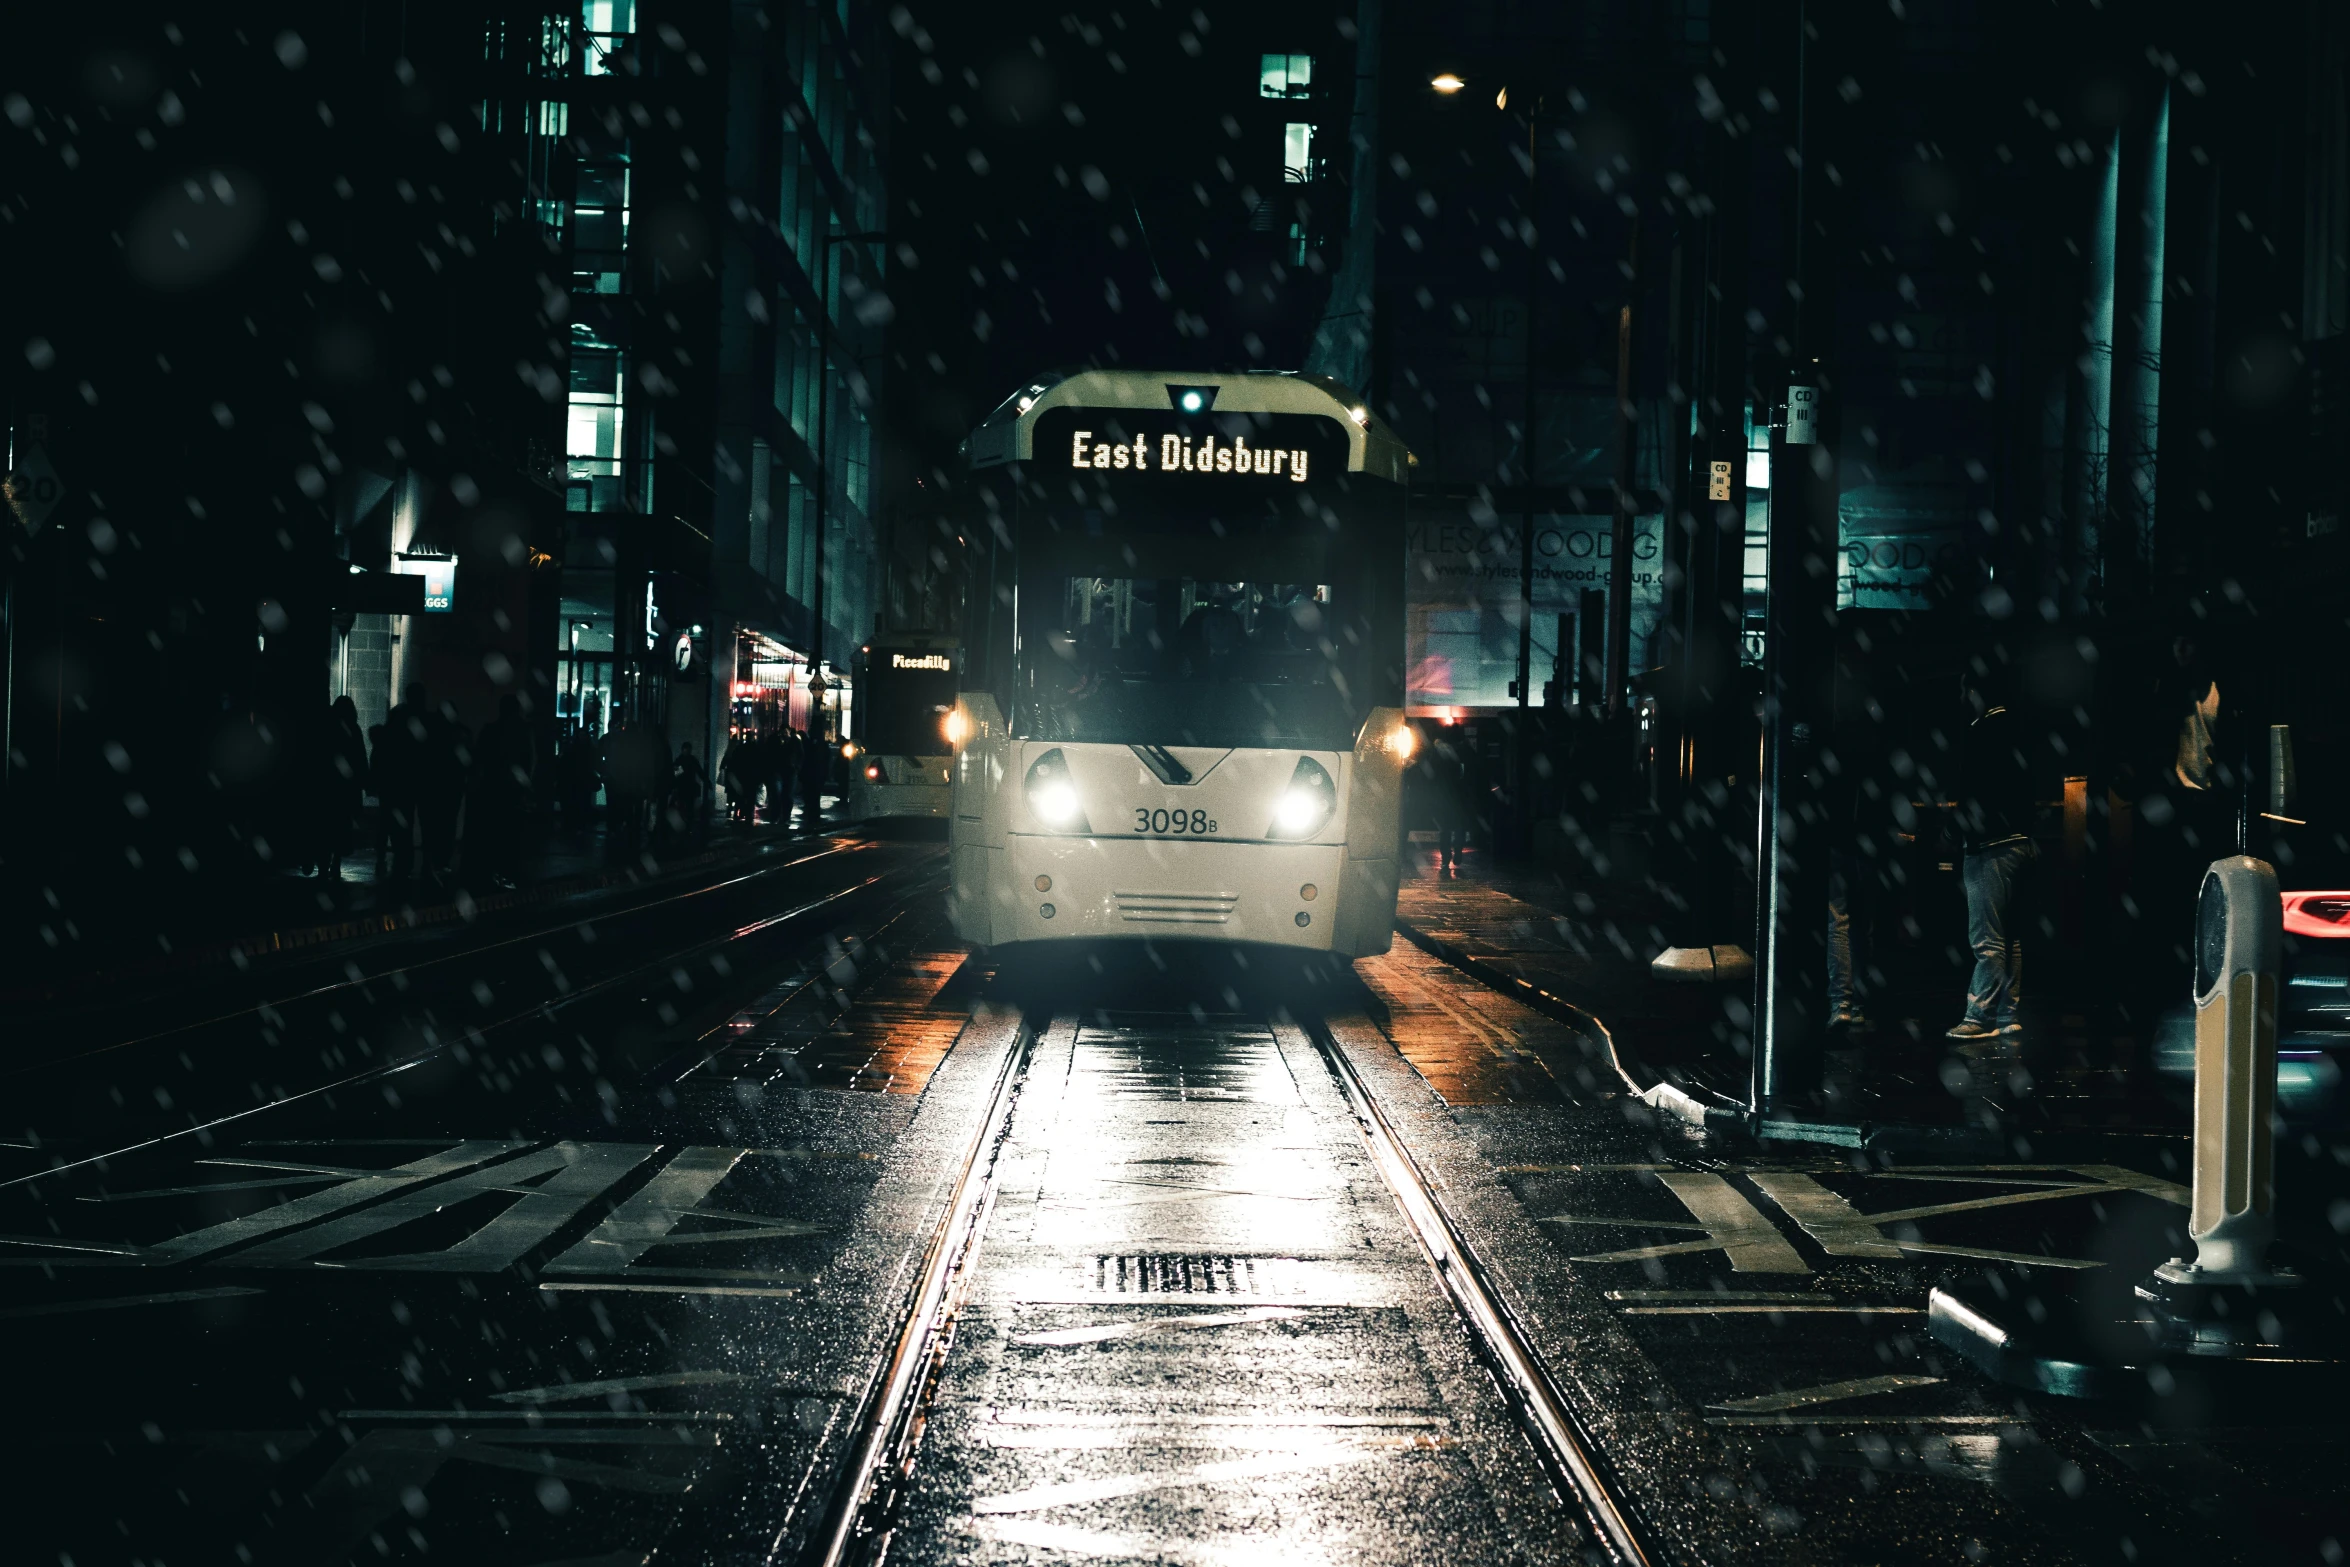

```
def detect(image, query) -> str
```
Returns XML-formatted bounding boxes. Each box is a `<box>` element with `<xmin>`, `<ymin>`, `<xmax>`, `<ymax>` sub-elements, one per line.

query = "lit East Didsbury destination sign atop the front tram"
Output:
<box><xmin>1034</xmin><ymin>409</ymin><xmax>1349</xmax><ymax>484</ymax></box>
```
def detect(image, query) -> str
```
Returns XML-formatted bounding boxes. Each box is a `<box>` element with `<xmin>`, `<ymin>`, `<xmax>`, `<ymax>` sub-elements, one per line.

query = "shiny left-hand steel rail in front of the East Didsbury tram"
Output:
<box><xmin>806</xmin><ymin>1017</ymin><xmax>1036</xmax><ymax>1567</ymax></box>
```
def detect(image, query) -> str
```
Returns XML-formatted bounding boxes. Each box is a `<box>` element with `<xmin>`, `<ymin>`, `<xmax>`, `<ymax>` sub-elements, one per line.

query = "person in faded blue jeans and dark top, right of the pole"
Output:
<box><xmin>1951</xmin><ymin>672</ymin><xmax>2040</xmax><ymax>1043</ymax></box>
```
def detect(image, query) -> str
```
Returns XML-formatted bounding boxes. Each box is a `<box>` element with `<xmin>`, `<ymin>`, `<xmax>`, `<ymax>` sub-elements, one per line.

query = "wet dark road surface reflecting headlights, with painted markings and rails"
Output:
<box><xmin>0</xmin><ymin>841</ymin><xmax>2350</xmax><ymax>1567</ymax></box>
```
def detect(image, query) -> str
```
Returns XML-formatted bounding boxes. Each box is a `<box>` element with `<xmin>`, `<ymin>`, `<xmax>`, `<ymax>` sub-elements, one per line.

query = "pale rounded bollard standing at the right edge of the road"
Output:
<box><xmin>2155</xmin><ymin>855</ymin><xmax>2296</xmax><ymax>1285</ymax></box>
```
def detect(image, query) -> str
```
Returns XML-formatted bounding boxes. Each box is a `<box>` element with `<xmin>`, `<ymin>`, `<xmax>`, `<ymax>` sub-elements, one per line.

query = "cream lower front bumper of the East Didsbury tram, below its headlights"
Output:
<box><xmin>992</xmin><ymin>834</ymin><xmax>1363</xmax><ymax>951</ymax></box>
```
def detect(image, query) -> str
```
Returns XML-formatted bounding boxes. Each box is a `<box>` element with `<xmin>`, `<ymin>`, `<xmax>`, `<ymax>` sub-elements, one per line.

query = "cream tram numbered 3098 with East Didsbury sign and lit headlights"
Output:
<box><xmin>949</xmin><ymin>369</ymin><xmax>1415</xmax><ymax>956</ymax></box>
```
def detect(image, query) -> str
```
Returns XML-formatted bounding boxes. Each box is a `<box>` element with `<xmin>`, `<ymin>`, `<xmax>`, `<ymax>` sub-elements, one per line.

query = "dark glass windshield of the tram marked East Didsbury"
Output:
<box><xmin>1020</xmin><ymin>576</ymin><xmax>1361</xmax><ymax>749</ymax></box>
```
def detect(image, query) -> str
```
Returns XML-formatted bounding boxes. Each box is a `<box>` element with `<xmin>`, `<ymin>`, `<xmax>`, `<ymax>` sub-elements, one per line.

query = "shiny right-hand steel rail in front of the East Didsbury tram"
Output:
<box><xmin>1304</xmin><ymin>1022</ymin><xmax>1659</xmax><ymax>1567</ymax></box>
